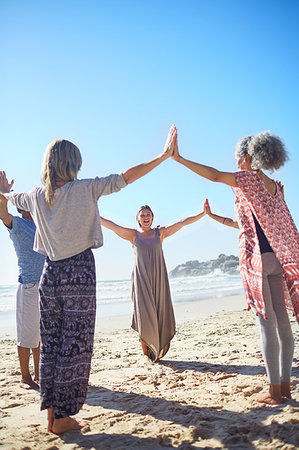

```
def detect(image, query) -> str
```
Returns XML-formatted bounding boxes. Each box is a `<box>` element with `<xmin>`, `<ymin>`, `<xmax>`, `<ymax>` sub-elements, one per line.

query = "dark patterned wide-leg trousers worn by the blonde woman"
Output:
<box><xmin>40</xmin><ymin>249</ymin><xmax>96</xmax><ymax>419</ymax></box>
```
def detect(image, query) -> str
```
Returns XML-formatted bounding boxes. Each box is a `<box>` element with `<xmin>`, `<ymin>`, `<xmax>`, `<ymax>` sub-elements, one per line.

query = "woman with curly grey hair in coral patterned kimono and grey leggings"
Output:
<box><xmin>173</xmin><ymin>128</ymin><xmax>299</xmax><ymax>404</ymax></box>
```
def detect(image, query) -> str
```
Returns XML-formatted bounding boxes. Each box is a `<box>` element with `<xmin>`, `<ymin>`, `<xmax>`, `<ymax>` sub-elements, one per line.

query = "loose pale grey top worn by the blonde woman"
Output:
<box><xmin>6</xmin><ymin>174</ymin><xmax>126</xmax><ymax>261</ymax></box>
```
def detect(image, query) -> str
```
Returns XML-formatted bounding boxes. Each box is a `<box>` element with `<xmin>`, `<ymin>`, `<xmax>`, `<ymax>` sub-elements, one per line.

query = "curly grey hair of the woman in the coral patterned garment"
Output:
<box><xmin>236</xmin><ymin>131</ymin><xmax>288</xmax><ymax>172</ymax></box>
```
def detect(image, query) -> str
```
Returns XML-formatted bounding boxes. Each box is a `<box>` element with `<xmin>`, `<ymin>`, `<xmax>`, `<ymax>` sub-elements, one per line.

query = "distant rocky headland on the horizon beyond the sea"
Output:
<box><xmin>169</xmin><ymin>253</ymin><xmax>239</xmax><ymax>278</ymax></box>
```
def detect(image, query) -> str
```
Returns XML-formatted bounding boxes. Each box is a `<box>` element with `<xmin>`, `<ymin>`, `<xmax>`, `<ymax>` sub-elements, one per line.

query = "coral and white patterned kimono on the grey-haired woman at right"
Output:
<box><xmin>233</xmin><ymin>170</ymin><xmax>299</xmax><ymax>322</ymax></box>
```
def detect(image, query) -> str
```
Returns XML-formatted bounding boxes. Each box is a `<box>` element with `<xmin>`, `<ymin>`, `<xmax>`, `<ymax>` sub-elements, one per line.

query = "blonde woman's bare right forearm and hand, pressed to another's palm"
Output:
<box><xmin>123</xmin><ymin>125</ymin><xmax>176</xmax><ymax>184</ymax></box>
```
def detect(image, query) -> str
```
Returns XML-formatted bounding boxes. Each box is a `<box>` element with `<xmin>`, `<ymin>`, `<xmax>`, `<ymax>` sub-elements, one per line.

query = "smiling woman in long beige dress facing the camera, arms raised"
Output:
<box><xmin>101</xmin><ymin>205</ymin><xmax>205</xmax><ymax>362</ymax></box>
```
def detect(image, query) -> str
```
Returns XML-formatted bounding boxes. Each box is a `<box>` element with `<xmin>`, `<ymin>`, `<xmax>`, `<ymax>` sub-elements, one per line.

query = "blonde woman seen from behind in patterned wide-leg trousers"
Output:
<box><xmin>0</xmin><ymin>128</ymin><xmax>174</xmax><ymax>434</ymax></box>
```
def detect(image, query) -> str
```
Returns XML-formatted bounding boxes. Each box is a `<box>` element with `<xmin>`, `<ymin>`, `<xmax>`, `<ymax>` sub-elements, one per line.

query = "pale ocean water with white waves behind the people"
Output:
<box><xmin>0</xmin><ymin>270</ymin><xmax>243</xmax><ymax>328</ymax></box>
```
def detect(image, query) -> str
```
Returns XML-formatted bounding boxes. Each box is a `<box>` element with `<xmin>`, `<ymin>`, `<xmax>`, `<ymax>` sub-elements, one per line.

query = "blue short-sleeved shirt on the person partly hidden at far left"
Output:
<box><xmin>7</xmin><ymin>216</ymin><xmax>45</xmax><ymax>284</ymax></box>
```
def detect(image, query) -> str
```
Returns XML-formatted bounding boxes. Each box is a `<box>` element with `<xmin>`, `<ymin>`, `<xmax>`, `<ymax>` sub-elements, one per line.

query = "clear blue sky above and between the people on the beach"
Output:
<box><xmin>0</xmin><ymin>0</ymin><xmax>299</xmax><ymax>284</ymax></box>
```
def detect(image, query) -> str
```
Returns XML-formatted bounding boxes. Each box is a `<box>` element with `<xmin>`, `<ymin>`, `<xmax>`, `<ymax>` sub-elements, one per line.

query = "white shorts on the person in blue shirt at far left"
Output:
<box><xmin>16</xmin><ymin>283</ymin><xmax>40</xmax><ymax>348</ymax></box>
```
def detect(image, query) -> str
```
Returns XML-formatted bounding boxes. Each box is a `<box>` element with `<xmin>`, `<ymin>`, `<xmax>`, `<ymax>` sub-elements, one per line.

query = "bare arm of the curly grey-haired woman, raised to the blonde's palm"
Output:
<box><xmin>172</xmin><ymin>134</ymin><xmax>238</xmax><ymax>187</ymax></box>
